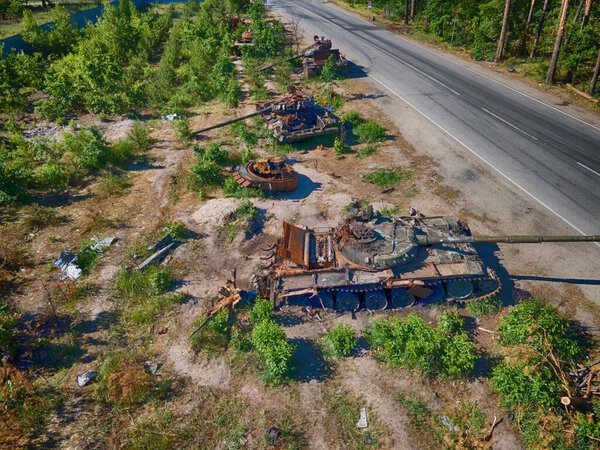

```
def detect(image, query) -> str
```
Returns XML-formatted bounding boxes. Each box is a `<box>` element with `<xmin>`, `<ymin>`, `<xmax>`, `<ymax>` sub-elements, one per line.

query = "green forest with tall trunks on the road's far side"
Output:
<box><xmin>346</xmin><ymin>0</ymin><xmax>600</xmax><ymax>95</ymax></box>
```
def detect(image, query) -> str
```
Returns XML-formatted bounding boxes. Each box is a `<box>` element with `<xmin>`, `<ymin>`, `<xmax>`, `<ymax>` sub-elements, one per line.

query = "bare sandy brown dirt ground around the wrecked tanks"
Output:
<box><xmin>2</xmin><ymin>14</ymin><xmax>600</xmax><ymax>449</ymax></box>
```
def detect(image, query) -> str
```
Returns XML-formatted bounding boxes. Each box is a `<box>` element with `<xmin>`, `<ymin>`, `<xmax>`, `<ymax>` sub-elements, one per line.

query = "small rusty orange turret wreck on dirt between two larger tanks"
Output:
<box><xmin>230</xmin><ymin>158</ymin><xmax>298</xmax><ymax>192</ymax></box>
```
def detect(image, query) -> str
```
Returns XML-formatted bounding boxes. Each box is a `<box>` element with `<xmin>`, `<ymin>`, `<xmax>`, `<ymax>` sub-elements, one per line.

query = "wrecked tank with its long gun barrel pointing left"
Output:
<box><xmin>195</xmin><ymin>93</ymin><xmax>340</xmax><ymax>143</ymax></box>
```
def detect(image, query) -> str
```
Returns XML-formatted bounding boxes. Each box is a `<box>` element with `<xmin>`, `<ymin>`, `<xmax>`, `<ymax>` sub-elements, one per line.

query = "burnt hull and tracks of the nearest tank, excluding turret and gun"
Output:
<box><xmin>267</xmin><ymin>217</ymin><xmax>500</xmax><ymax>312</ymax></box>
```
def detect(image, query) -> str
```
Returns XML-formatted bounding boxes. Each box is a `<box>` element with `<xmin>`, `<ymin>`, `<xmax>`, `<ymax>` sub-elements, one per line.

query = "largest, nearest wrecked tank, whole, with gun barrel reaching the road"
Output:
<box><xmin>254</xmin><ymin>208</ymin><xmax>600</xmax><ymax>312</ymax></box>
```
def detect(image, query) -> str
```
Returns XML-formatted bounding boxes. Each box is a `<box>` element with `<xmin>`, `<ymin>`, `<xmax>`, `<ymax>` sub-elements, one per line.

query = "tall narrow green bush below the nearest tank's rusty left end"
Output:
<box><xmin>252</xmin><ymin>320</ymin><xmax>294</xmax><ymax>383</ymax></box>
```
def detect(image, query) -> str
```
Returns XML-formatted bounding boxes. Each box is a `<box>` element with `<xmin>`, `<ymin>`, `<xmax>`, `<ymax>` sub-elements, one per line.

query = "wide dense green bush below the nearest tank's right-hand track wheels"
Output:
<box><xmin>368</xmin><ymin>313</ymin><xmax>476</xmax><ymax>378</ymax></box>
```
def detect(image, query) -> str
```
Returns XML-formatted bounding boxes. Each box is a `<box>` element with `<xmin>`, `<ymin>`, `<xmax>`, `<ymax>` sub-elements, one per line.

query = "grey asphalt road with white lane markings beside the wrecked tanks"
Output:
<box><xmin>267</xmin><ymin>0</ymin><xmax>600</xmax><ymax>234</ymax></box>
